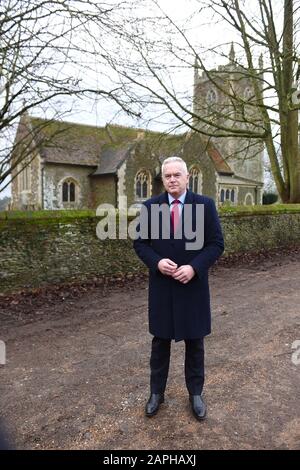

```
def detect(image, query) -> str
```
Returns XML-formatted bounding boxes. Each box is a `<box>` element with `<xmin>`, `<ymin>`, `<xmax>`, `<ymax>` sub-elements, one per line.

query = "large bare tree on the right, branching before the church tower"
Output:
<box><xmin>101</xmin><ymin>0</ymin><xmax>300</xmax><ymax>203</ymax></box>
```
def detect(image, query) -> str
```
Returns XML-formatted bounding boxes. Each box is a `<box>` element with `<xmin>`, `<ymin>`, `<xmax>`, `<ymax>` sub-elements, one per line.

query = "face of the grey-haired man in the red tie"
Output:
<box><xmin>162</xmin><ymin>162</ymin><xmax>189</xmax><ymax>199</ymax></box>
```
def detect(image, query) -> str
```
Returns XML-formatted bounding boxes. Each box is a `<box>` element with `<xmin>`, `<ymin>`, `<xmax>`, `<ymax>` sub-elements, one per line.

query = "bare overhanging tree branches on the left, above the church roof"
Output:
<box><xmin>0</xmin><ymin>0</ymin><xmax>141</xmax><ymax>190</ymax></box>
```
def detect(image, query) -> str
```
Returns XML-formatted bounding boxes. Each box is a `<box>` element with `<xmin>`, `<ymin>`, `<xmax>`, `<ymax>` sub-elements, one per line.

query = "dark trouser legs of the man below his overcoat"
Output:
<box><xmin>150</xmin><ymin>336</ymin><xmax>204</xmax><ymax>395</ymax></box>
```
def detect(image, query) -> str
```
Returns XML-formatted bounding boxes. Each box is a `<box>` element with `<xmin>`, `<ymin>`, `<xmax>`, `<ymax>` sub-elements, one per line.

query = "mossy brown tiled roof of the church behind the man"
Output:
<box><xmin>20</xmin><ymin>116</ymin><xmax>233</xmax><ymax>176</ymax></box>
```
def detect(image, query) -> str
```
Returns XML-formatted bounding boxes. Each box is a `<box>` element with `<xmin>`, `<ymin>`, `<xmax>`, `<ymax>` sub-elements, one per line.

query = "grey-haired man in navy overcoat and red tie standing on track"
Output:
<box><xmin>134</xmin><ymin>157</ymin><xmax>224</xmax><ymax>420</ymax></box>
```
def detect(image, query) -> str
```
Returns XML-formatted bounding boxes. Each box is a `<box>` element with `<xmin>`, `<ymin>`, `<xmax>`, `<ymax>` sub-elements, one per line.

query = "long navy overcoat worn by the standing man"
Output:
<box><xmin>134</xmin><ymin>190</ymin><xmax>224</xmax><ymax>341</ymax></box>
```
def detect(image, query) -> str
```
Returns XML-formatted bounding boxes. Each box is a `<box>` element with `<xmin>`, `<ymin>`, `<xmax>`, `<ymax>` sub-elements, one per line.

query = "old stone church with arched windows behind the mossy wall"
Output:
<box><xmin>11</xmin><ymin>49</ymin><xmax>263</xmax><ymax>210</ymax></box>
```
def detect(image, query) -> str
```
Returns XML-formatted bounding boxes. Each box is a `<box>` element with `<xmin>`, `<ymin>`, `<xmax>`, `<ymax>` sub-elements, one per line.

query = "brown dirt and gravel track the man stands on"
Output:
<box><xmin>0</xmin><ymin>249</ymin><xmax>300</xmax><ymax>450</ymax></box>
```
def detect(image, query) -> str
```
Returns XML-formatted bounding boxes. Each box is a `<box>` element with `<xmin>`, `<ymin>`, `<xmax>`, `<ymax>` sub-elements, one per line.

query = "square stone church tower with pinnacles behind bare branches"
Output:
<box><xmin>193</xmin><ymin>43</ymin><xmax>263</xmax><ymax>183</ymax></box>
